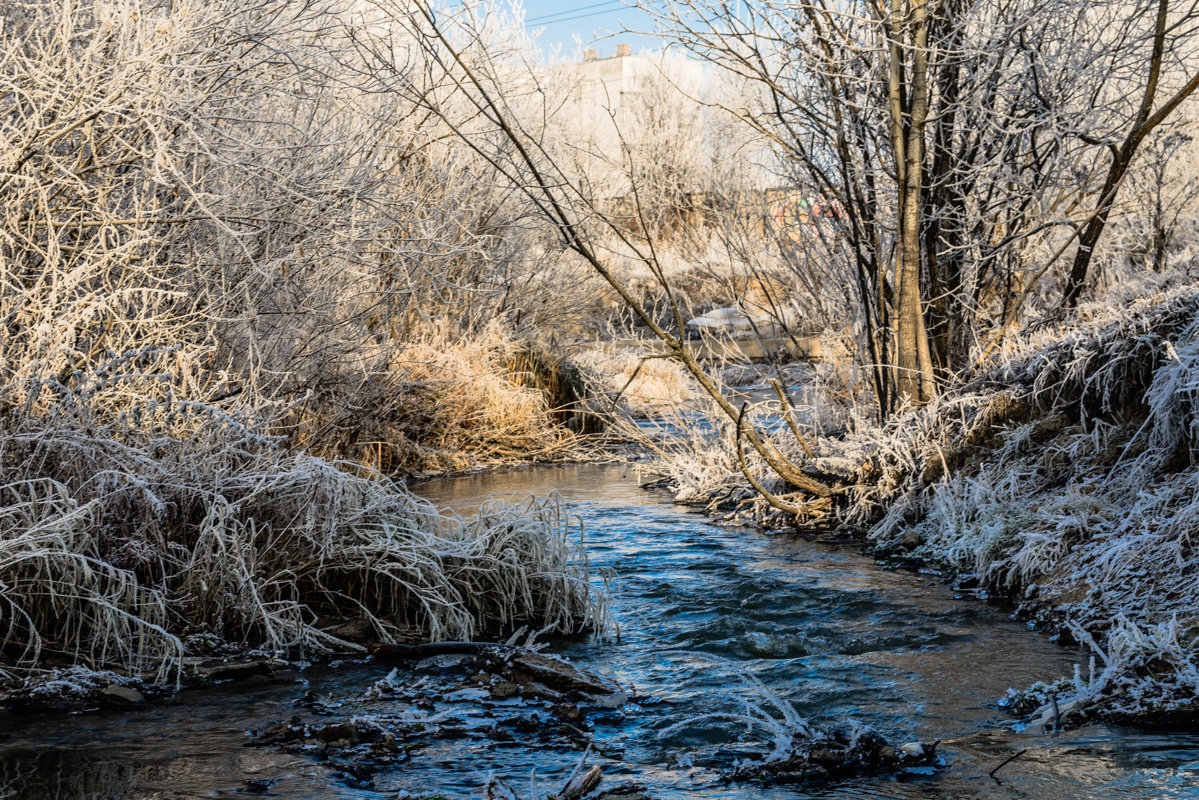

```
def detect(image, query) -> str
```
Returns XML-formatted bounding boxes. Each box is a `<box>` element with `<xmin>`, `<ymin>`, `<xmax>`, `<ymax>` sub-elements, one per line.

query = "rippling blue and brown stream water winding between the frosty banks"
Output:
<box><xmin>0</xmin><ymin>465</ymin><xmax>1199</xmax><ymax>800</ymax></box>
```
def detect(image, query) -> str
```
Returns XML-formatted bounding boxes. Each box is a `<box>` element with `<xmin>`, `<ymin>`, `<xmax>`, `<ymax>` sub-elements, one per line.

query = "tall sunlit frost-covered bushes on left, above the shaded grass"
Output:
<box><xmin>0</xmin><ymin>0</ymin><xmax>589</xmax><ymax>471</ymax></box>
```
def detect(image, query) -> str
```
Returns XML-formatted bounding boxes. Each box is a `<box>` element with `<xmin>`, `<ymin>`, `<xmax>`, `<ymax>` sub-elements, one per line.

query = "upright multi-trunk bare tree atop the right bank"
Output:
<box><xmin>649</xmin><ymin>0</ymin><xmax>1195</xmax><ymax>411</ymax></box>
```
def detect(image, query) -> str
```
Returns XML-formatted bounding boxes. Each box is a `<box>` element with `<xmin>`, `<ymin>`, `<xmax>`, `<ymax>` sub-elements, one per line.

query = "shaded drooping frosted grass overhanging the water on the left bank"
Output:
<box><xmin>0</xmin><ymin>391</ymin><xmax>600</xmax><ymax>682</ymax></box>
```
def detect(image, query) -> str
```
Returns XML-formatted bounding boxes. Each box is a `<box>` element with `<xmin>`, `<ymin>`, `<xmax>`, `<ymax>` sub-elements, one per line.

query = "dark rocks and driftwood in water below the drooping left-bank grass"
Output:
<box><xmin>249</xmin><ymin>642</ymin><xmax>632</xmax><ymax>798</ymax></box>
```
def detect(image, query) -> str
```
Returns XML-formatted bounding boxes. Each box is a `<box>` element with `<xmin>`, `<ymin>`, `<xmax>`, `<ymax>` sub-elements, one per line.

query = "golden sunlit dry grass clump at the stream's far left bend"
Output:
<box><xmin>291</xmin><ymin>326</ymin><xmax>594</xmax><ymax>475</ymax></box>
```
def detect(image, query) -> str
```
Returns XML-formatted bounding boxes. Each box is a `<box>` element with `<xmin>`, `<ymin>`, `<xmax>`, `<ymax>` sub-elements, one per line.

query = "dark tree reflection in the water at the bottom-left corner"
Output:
<box><xmin>0</xmin><ymin>750</ymin><xmax>138</xmax><ymax>800</ymax></box>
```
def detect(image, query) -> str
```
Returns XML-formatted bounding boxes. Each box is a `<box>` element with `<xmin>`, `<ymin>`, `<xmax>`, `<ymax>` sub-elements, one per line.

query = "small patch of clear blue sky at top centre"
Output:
<box><xmin>524</xmin><ymin>0</ymin><xmax>662</xmax><ymax>56</ymax></box>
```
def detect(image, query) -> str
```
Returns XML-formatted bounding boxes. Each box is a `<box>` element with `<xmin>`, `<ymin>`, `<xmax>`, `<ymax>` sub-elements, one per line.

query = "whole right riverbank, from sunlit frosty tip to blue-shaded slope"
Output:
<box><xmin>664</xmin><ymin>285</ymin><xmax>1199</xmax><ymax>724</ymax></box>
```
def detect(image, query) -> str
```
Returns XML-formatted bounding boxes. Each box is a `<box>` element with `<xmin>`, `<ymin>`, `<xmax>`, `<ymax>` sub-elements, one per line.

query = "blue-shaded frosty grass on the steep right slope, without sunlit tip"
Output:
<box><xmin>870</xmin><ymin>287</ymin><xmax>1199</xmax><ymax>721</ymax></box>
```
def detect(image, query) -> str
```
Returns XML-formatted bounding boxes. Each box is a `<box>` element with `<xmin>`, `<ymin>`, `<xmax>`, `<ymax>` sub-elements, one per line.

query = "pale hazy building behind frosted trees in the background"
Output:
<box><xmin>555</xmin><ymin>44</ymin><xmax>820</xmax><ymax>239</ymax></box>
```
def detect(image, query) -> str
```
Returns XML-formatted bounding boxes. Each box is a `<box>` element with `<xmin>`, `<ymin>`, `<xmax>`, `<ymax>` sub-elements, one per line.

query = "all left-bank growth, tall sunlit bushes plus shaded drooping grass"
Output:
<box><xmin>0</xmin><ymin>0</ymin><xmax>598</xmax><ymax>681</ymax></box>
